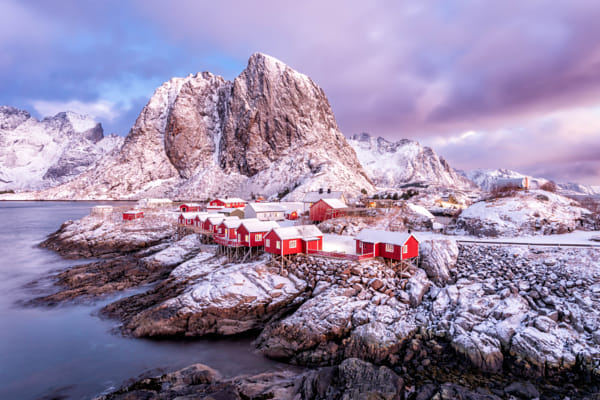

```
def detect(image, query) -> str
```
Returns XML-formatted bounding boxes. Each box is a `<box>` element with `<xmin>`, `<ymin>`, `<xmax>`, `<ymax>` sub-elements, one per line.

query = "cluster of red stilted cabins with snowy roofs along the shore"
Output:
<box><xmin>98</xmin><ymin>189</ymin><xmax>419</xmax><ymax>270</ymax></box>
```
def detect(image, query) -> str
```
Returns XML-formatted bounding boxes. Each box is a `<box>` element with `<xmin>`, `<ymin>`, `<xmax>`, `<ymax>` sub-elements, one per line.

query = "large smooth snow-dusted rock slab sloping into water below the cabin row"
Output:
<box><xmin>124</xmin><ymin>253</ymin><xmax>307</xmax><ymax>336</ymax></box>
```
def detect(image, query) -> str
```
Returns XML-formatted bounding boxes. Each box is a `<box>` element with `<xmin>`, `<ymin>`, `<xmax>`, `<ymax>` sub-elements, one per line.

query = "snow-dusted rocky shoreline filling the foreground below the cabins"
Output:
<box><xmin>33</xmin><ymin>217</ymin><xmax>600</xmax><ymax>399</ymax></box>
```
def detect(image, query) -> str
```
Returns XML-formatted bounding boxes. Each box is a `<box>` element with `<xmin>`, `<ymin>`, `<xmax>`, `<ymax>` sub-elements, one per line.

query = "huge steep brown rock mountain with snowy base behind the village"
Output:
<box><xmin>34</xmin><ymin>53</ymin><xmax>374</xmax><ymax>200</ymax></box>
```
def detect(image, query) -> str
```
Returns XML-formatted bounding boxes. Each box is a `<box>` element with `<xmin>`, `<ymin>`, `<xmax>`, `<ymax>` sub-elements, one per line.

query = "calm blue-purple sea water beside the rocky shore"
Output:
<box><xmin>0</xmin><ymin>202</ymin><xmax>285</xmax><ymax>400</ymax></box>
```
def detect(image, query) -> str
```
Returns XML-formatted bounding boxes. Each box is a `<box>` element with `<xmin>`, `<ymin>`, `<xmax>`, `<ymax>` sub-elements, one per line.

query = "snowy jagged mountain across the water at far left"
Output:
<box><xmin>0</xmin><ymin>106</ymin><xmax>123</xmax><ymax>191</ymax></box>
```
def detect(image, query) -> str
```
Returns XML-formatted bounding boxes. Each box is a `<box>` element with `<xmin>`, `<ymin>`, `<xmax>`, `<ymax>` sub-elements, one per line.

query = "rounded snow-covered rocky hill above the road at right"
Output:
<box><xmin>456</xmin><ymin>190</ymin><xmax>595</xmax><ymax>237</ymax></box>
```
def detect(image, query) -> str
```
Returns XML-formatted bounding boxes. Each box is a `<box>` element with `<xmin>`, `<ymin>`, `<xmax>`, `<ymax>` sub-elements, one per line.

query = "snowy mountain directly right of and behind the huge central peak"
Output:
<box><xmin>348</xmin><ymin>133</ymin><xmax>476</xmax><ymax>189</ymax></box>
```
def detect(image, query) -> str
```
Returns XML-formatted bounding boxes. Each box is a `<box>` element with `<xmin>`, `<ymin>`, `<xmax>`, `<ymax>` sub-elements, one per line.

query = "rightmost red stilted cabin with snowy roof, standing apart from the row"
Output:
<box><xmin>354</xmin><ymin>229</ymin><xmax>419</xmax><ymax>261</ymax></box>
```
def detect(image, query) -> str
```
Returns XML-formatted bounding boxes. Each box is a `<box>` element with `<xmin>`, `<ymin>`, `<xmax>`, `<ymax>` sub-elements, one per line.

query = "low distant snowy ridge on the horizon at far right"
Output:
<box><xmin>465</xmin><ymin>169</ymin><xmax>600</xmax><ymax>195</ymax></box>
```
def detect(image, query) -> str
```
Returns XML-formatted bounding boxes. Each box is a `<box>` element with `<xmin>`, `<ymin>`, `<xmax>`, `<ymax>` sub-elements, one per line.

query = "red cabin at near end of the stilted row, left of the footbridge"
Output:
<box><xmin>265</xmin><ymin>225</ymin><xmax>323</xmax><ymax>256</ymax></box>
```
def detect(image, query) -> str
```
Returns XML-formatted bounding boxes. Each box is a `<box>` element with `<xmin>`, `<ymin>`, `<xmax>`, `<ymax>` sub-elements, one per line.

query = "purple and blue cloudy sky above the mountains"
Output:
<box><xmin>0</xmin><ymin>0</ymin><xmax>600</xmax><ymax>185</ymax></box>
